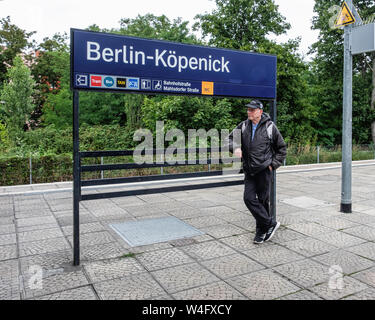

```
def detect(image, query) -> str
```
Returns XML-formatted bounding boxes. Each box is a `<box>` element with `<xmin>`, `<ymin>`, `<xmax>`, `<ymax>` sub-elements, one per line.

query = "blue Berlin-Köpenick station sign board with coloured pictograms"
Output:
<box><xmin>71</xmin><ymin>29</ymin><xmax>277</xmax><ymax>99</ymax></box>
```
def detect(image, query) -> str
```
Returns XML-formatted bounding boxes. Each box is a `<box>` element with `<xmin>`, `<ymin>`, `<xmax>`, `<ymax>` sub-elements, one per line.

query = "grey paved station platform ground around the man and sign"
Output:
<box><xmin>0</xmin><ymin>161</ymin><xmax>375</xmax><ymax>300</ymax></box>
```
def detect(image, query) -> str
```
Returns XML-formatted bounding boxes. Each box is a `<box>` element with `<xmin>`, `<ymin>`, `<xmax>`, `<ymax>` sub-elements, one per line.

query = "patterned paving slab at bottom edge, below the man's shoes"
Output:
<box><xmin>227</xmin><ymin>270</ymin><xmax>301</xmax><ymax>300</ymax></box>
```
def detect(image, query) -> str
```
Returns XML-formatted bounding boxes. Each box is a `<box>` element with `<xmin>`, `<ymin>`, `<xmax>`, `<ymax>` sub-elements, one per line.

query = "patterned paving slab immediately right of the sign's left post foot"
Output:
<box><xmin>83</xmin><ymin>257</ymin><xmax>146</xmax><ymax>283</ymax></box>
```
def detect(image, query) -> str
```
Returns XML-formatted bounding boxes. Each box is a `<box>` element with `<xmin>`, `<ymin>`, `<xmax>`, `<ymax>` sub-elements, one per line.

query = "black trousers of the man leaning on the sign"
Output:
<box><xmin>244</xmin><ymin>168</ymin><xmax>276</xmax><ymax>233</ymax></box>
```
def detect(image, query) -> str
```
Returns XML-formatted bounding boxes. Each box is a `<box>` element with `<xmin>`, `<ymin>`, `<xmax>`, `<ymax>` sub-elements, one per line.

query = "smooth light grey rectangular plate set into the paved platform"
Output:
<box><xmin>109</xmin><ymin>217</ymin><xmax>204</xmax><ymax>247</ymax></box>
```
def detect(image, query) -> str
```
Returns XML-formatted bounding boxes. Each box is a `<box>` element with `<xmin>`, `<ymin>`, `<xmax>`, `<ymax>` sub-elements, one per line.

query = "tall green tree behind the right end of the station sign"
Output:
<box><xmin>195</xmin><ymin>0</ymin><xmax>316</xmax><ymax>143</ymax></box>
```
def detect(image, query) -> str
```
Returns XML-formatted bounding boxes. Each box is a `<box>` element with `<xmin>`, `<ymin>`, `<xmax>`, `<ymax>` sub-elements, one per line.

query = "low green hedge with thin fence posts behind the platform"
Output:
<box><xmin>0</xmin><ymin>144</ymin><xmax>375</xmax><ymax>185</ymax></box>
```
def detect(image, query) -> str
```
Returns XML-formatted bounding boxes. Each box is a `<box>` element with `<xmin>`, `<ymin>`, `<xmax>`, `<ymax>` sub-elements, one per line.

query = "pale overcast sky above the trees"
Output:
<box><xmin>0</xmin><ymin>0</ymin><xmax>318</xmax><ymax>59</ymax></box>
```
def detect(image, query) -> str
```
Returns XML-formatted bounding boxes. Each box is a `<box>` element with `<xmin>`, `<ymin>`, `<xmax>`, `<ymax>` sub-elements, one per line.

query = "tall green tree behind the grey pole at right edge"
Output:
<box><xmin>310</xmin><ymin>0</ymin><xmax>375</xmax><ymax>145</ymax></box>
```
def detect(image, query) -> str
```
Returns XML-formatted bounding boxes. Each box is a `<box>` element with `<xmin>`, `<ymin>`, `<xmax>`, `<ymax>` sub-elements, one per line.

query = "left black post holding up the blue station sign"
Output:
<box><xmin>73</xmin><ymin>90</ymin><xmax>81</xmax><ymax>266</ymax></box>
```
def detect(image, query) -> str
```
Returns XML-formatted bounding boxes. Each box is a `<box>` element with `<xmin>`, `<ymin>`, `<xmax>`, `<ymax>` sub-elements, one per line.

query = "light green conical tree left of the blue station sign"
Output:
<box><xmin>0</xmin><ymin>56</ymin><xmax>35</xmax><ymax>142</ymax></box>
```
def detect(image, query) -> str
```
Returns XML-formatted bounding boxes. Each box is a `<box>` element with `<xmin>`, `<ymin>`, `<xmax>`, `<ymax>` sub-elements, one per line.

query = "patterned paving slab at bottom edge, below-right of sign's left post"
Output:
<box><xmin>94</xmin><ymin>273</ymin><xmax>166</xmax><ymax>300</ymax></box>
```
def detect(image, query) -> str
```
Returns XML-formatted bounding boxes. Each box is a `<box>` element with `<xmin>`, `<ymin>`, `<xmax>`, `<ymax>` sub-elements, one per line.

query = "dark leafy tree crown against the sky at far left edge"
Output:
<box><xmin>0</xmin><ymin>16</ymin><xmax>35</xmax><ymax>86</ymax></box>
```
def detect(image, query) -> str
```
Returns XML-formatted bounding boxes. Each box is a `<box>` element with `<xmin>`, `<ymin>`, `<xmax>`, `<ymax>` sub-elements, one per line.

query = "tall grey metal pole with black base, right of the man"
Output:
<box><xmin>340</xmin><ymin>1</ymin><xmax>353</xmax><ymax>213</ymax></box>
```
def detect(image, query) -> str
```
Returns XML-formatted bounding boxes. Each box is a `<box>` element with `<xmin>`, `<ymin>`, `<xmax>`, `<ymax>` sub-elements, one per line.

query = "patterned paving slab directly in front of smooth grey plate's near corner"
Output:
<box><xmin>137</xmin><ymin>248</ymin><xmax>194</xmax><ymax>271</ymax></box>
